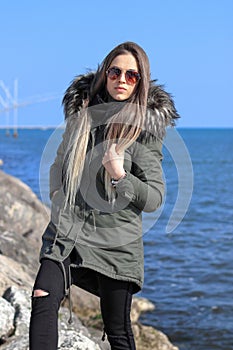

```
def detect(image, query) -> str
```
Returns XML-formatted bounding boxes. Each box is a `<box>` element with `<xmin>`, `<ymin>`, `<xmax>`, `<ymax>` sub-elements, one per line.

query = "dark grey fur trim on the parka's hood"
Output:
<box><xmin>62</xmin><ymin>73</ymin><xmax>179</xmax><ymax>138</ymax></box>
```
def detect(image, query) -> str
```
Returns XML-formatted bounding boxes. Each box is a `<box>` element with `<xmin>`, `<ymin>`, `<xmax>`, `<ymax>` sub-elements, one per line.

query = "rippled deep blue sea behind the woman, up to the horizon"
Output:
<box><xmin>0</xmin><ymin>128</ymin><xmax>233</xmax><ymax>350</ymax></box>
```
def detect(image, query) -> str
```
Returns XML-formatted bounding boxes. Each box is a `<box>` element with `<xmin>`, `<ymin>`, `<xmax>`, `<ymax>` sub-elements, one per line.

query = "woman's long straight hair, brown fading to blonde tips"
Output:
<box><xmin>64</xmin><ymin>42</ymin><xmax>150</xmax><ymax>205</ymax></box>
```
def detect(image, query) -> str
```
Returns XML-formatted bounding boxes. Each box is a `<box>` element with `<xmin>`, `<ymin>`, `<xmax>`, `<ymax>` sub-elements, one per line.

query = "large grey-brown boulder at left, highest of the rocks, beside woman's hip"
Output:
<box><xmin>0</xmin><ymin>171</ymin><xmax>49</xmax><ymax>254</ymax></box>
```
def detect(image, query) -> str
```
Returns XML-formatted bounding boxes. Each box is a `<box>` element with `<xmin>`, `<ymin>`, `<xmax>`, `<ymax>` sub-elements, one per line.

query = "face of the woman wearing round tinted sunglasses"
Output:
<box><xmin>107</xmin><ymin>53</ymin><xmax>138</xmax><ymax>101</ymax></box>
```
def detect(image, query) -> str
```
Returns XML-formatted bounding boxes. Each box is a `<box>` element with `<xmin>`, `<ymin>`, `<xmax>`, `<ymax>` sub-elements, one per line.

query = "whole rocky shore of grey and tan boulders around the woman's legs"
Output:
<box><xmin>0</xmin><ymin>171</ymin><xmax>178</xmax><ymax>350</ymax></box>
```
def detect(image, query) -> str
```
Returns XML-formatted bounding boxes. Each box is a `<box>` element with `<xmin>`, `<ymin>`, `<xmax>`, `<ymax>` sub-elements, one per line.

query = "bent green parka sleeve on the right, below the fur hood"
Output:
<box><xmin>116</xmin><ymin>140</ymin><xmax>164</xmax><ymax>212</ymax></box>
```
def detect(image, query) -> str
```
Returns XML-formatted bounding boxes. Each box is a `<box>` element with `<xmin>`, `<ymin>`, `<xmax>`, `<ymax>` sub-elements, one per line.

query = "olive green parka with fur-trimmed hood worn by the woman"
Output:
<box><xmin>40</xmin><ymin>73</ymin><xmax>178</xmax><ymax>295</ymax></box>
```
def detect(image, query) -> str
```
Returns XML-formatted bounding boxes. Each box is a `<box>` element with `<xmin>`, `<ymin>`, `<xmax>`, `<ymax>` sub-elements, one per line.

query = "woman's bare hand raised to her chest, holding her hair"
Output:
<box><xmin>102</xmin><ymin>143</ymin><xmax>125</xmax><ymax>180</ymax></box>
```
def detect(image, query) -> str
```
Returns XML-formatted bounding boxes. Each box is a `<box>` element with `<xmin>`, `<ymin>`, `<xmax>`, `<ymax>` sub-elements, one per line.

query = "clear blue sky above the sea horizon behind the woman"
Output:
<box><xmin>0</xmin><ymin>0</ymin><xmax>233</xmax><ymax>127</ymax></box>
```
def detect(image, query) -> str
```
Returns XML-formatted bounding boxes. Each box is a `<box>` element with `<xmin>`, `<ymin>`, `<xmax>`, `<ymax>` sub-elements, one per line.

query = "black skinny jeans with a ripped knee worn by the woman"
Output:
<box><xmin>29</xmin><ymin>258</ymin><xmax>136</xmax><ymax>350</ymax></box>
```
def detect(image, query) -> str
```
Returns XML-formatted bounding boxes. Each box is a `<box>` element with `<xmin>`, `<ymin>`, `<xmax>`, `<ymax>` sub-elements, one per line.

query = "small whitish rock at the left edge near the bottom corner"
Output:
<box><xmin>0</xmin><ymin>298</ymin><xmax>15</xmax><ymax>342</ymax></box>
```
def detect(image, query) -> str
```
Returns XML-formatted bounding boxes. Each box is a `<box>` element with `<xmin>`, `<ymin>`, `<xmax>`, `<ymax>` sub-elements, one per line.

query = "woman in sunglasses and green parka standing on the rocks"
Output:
<box><xmin>30</xmin><ymin>42</ymin><xmax>178</xmax><ymax>350</ymax></box>
